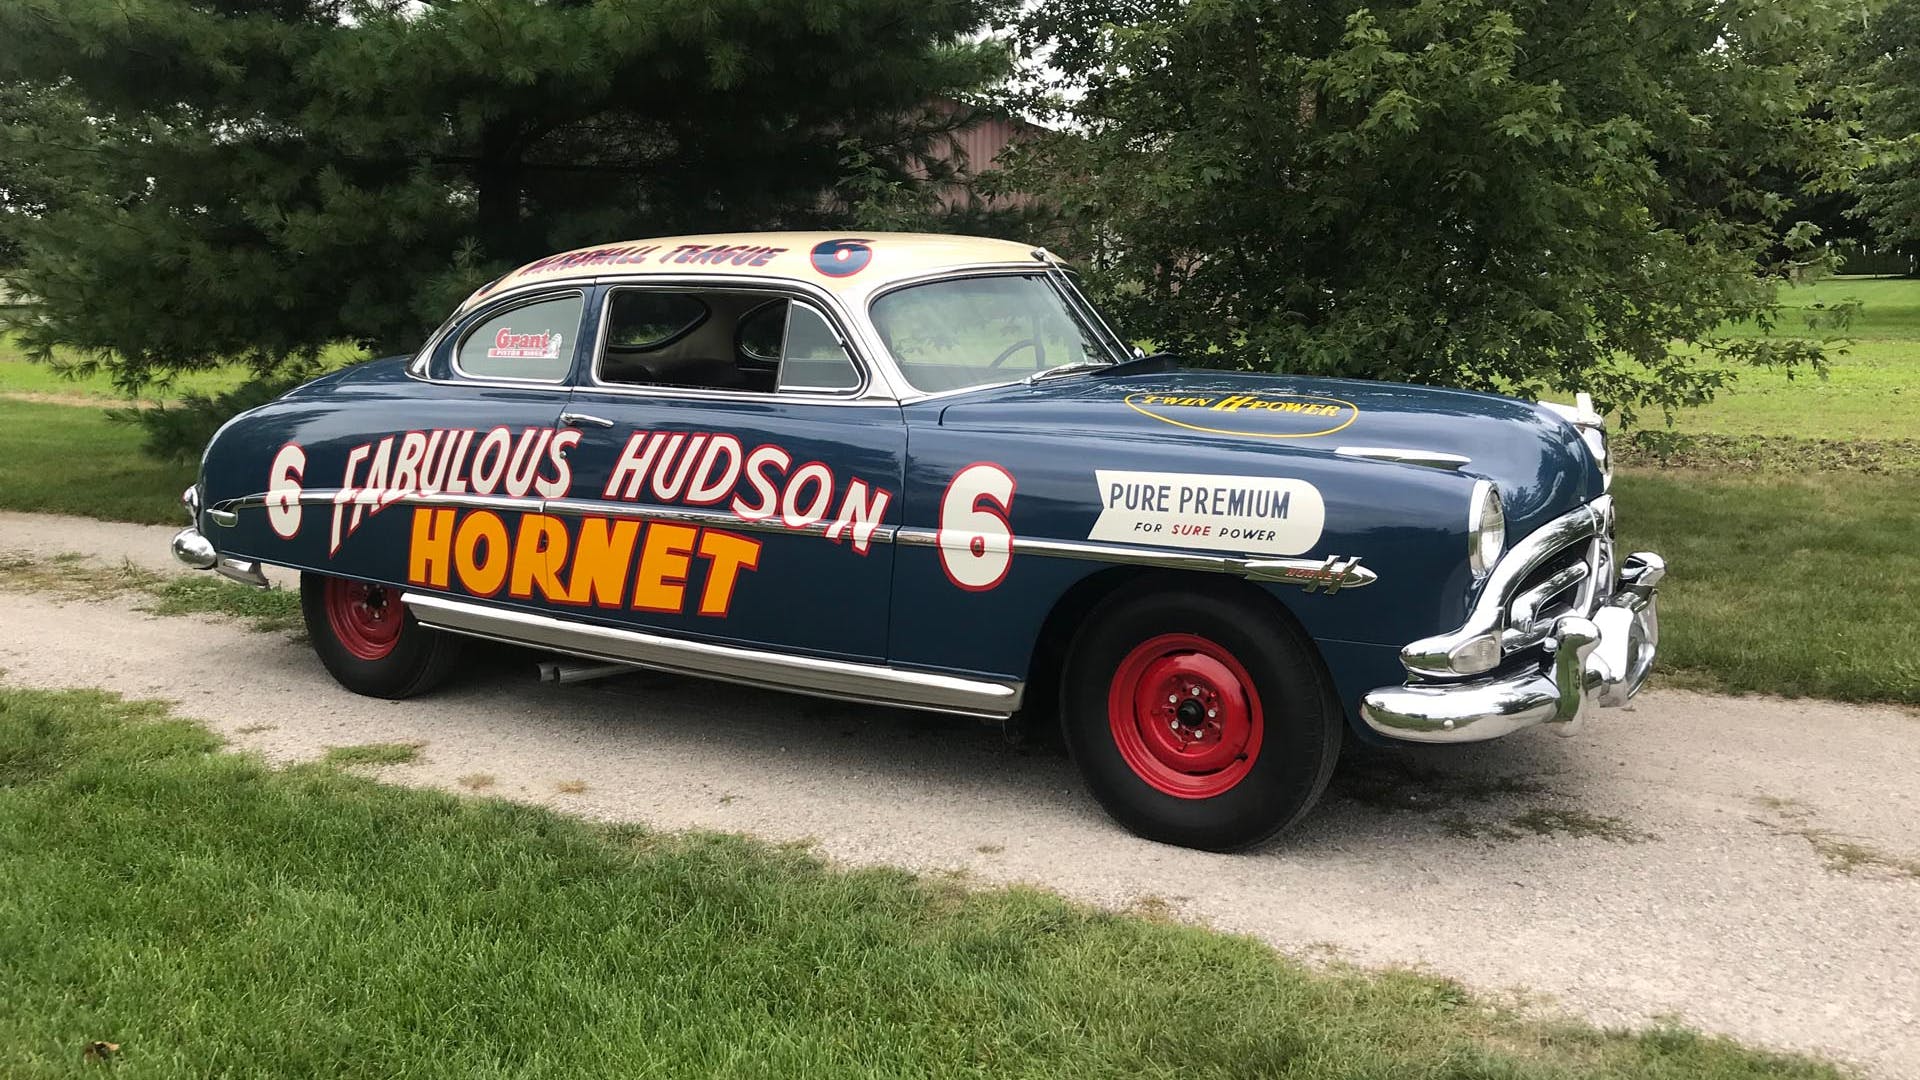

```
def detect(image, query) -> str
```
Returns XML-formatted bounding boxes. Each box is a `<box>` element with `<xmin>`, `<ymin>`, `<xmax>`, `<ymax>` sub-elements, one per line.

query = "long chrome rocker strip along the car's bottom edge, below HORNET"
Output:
<box><xmin>401</xmin><ymin>592</ymin><xmax>1025</xmax><ymax>719</ymax></box>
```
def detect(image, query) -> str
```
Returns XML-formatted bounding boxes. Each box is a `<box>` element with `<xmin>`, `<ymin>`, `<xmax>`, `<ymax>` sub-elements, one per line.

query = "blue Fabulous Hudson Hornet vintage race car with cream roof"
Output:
<box><xmin>173</xmin><ymin>234</ymin><xmax>1665</xmax><ymax>849</ymax></box>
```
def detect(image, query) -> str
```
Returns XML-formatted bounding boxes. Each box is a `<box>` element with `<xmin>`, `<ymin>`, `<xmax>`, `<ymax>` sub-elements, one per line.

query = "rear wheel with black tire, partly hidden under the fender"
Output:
<box><xmin>300</xmin><ymin>573</ymin><xmax>465</xmax><ymax>700</ymax></box>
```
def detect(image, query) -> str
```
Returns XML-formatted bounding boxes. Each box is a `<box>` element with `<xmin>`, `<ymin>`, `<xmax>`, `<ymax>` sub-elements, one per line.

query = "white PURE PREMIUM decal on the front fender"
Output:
<box><xmin>1087</xmin><ymin>469</ymin><xmax>1327</xmax><ymax>555</ymax></box>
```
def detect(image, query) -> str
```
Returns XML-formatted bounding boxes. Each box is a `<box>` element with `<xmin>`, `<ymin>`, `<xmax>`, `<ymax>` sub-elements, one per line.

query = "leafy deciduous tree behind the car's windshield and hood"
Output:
<box><xmin>1010</xmin><ymin>0</ymin><xmax>1851</xmax><ymax>421</ymax></box>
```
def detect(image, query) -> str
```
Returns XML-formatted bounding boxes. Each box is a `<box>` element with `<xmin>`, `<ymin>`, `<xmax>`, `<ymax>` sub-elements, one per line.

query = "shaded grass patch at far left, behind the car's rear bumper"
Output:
<box><xmin>0</xmin><ymin>400</ymin><xmax>196</xmax><ymax>525</ymax></box>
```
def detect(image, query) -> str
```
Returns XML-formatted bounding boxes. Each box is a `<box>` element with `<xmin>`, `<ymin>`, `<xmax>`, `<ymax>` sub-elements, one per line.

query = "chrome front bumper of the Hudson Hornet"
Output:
<box><xmin>1359</xmin><ymin>552</ymin><xmax>1667</xmax><ymax>742</ymax></box>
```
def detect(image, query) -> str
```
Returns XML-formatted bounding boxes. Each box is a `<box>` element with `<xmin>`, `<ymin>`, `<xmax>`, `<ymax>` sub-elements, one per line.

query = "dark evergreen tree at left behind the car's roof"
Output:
<box><xmin>0</xmin><ymin>0</ymin><xmax>1006</xmax><ymax>386</ymax></box>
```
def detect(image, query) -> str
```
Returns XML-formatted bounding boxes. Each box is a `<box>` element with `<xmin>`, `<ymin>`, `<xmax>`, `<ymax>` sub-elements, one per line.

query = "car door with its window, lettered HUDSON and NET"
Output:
<box><xmin>547</xmin><ymin>282</ymin><xmax>906</xmax><ymax>659</ymax></box>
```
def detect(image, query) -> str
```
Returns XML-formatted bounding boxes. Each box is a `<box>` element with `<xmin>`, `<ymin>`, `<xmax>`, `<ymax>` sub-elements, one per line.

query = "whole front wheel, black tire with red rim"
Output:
<box><xmin>1062</xmin><ymin>578</ymin><xmax>1346</xmax><ymax>851</ymax></box>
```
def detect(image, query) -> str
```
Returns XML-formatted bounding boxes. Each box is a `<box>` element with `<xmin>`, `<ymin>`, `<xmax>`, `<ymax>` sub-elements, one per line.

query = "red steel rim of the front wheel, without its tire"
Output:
<box><xmin>1106</xmin><ymin>634</ymin><xmax>1265</xmax><ymax>799</ymax></box>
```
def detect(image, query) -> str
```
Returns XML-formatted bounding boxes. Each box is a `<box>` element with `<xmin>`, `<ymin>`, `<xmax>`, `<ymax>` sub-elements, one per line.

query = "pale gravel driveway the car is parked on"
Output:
<box><xmin>0</xmin><ymin>513</ymin><xmax>1920</xmax><ymax>1076</ymax></box>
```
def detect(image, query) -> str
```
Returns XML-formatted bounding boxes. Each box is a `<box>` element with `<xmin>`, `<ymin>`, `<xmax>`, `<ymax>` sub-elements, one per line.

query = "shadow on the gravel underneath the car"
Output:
<box><xmin>444</xmin><ymin>648</ymin><xmax>1653</xmax><ymax>857</ymax></box>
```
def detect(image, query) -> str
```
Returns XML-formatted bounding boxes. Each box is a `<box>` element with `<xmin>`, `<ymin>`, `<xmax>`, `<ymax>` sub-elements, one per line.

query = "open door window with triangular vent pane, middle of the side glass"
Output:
<box><xmin>599</xmin><ymin>288</ymin><xmax>860</xmax><ymax>394</ymax></box>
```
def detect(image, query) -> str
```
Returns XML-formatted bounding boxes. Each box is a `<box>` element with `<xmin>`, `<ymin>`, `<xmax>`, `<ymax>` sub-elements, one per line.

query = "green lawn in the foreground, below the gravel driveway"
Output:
<box><xmin>0</xmin><ymin>688</ymin><xmax>1837</xmax><ymax>1080</ymax></box>
